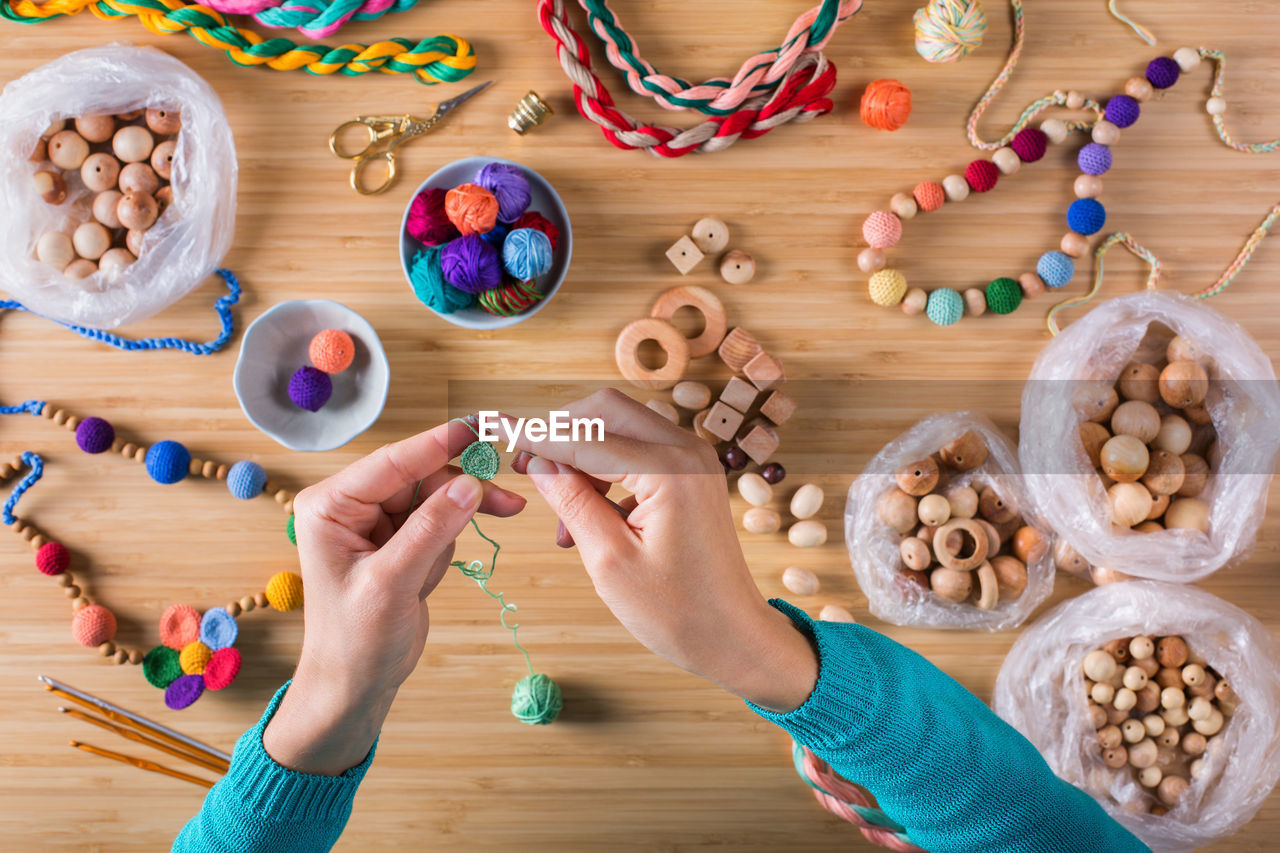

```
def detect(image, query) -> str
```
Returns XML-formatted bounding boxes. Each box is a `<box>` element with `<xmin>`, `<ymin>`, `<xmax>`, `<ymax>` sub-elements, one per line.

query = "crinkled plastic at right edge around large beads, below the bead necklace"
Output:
<box><xmin>1019</xmin><ymin>291</ymin><xmax>1280</xmax><ymax>581</ymax></box>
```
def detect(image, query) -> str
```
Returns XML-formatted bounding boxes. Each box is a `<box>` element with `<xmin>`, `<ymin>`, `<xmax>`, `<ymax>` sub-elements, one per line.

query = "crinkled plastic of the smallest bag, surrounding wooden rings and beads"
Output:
<box><xmin>845</xmin><ymin>411</ymin><xmax>1053</xmax><ymax>631</ymax></box>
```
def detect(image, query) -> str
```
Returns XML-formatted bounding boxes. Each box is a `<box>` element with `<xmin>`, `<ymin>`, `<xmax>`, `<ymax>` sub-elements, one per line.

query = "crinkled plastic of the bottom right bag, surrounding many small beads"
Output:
<box><xmin>993</xmin><ymin>580</ymin><xmax>1280</xmax><ymax>852</ymax></box>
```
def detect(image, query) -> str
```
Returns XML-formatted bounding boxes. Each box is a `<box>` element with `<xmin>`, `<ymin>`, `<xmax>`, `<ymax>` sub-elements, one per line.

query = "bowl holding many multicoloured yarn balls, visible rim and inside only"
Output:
<box><xmin>401</xmin><ymin>158</ymin><xmax>573</xmax><ymax>329</ymax></box>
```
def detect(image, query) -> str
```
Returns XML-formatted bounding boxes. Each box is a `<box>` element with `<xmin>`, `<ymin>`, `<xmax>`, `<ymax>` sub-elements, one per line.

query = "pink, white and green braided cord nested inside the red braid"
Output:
<box><xmin>580</xmin><ymin>0</ymin><xmax>863</xmax><ymax>115</ymax></box>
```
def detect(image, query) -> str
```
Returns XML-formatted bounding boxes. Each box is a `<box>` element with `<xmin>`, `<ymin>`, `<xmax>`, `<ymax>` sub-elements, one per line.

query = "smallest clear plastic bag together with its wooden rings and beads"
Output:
<box><xmin>845</xmin><ymin>411</ymin><xmax>1053</xmax><ymax>631</ymax></box>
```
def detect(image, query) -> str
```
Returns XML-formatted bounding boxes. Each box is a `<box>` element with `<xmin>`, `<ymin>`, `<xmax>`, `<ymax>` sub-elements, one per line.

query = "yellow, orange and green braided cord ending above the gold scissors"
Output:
<box><xmin>0</xmin><ymin>0</ymin><xmax>476</xmax><ymax>86</ymax></box>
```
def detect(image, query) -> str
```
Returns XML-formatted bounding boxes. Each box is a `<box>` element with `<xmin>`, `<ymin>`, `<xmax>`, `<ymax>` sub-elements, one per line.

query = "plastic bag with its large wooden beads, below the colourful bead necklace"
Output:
<box><xmin>1019</xmin><ymin>291</ymin><xmax>1280</xmax><ymax>581</ymax></box>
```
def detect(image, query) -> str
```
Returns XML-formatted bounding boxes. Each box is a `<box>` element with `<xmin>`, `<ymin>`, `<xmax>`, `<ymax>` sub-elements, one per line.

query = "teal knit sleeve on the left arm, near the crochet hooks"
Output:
<box><xmin>173</xmin><ymin>684</ymin><xmax>376</xmax><ymax>853</ymax></box>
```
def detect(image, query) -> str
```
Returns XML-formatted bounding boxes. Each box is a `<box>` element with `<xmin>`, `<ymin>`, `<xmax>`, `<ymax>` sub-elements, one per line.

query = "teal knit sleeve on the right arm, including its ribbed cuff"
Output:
<box><xmin>749</xmin><ymin>599</ymin><xmax>1151</xmax><ymax>853</ymax></box>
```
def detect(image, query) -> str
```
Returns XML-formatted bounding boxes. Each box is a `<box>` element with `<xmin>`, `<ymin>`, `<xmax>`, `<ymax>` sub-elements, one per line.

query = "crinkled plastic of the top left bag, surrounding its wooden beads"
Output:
<box><xmin>0</xmin><ymin>45</ymin><xmax>237</xmax><ymax>329</ymax></box>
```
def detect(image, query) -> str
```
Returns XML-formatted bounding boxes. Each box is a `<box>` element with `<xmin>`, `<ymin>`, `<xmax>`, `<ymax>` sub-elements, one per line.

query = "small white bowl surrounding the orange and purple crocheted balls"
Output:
<box><xmin>233</xmin><ymin>300</ymin><xmax>392</xmax><ymax>451</ymax></box>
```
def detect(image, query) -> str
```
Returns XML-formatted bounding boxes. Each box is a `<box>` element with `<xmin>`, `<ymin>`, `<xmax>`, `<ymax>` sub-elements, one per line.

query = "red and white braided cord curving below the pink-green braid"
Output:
<box><xmin>538</xmin><ymin>0</ymin><xmax>836</xmax><ymax>158</ymax></box>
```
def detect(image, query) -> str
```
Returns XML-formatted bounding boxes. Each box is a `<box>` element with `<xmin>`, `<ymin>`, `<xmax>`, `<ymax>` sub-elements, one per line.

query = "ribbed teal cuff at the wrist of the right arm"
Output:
<box><xmin>746</xmin><ymin>598</ymin><xmax>879</xmax><ymax>749</ymax></box>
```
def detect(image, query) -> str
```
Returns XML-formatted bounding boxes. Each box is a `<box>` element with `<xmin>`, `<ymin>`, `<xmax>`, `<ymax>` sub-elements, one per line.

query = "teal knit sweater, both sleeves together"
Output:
<box><xmin>173</xmin><ymin>601</ymin><xmax>1151</xmax><ymax>853</ymax></box>
